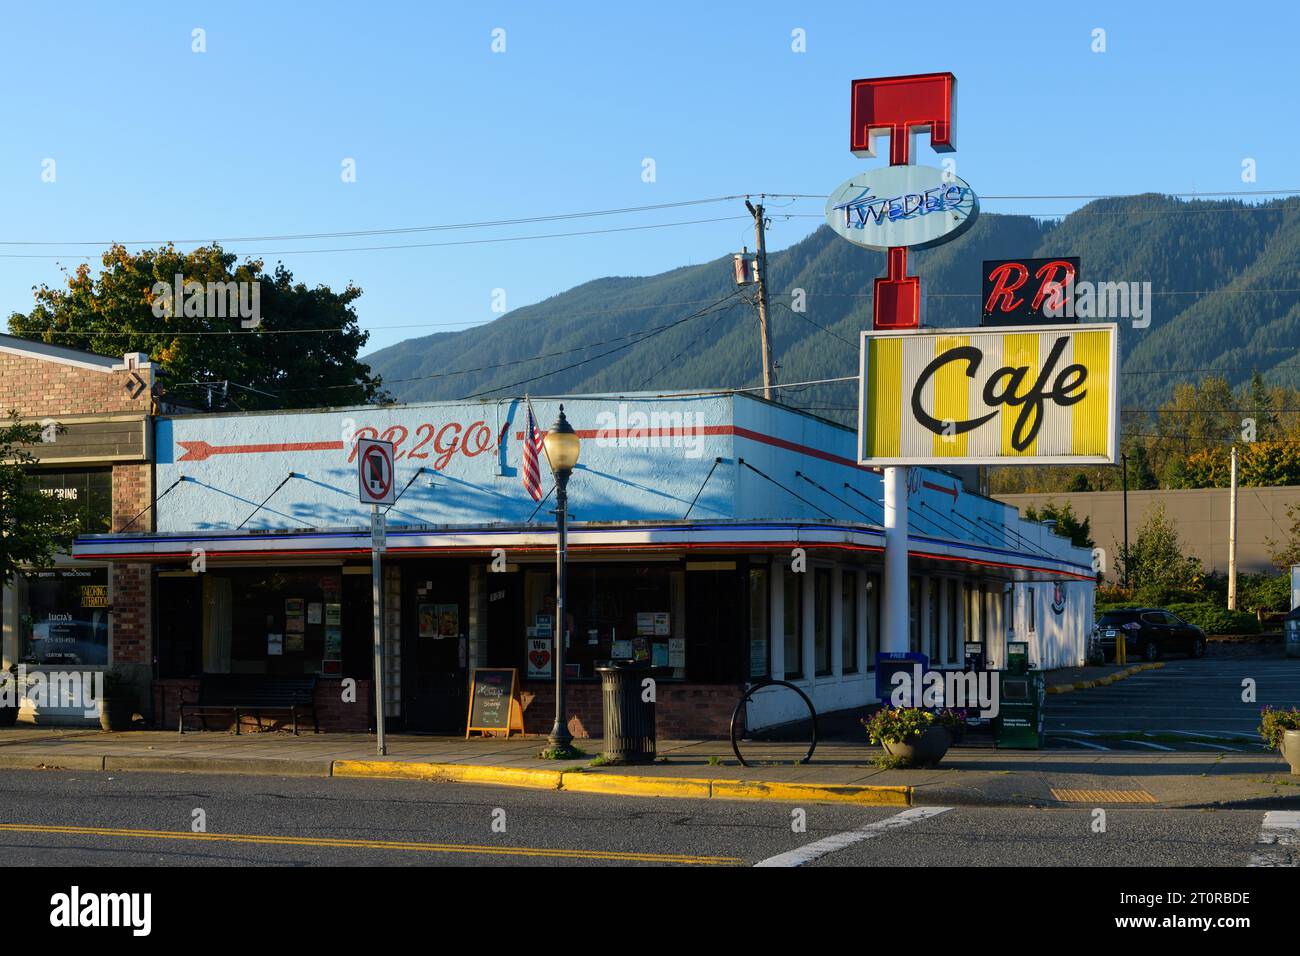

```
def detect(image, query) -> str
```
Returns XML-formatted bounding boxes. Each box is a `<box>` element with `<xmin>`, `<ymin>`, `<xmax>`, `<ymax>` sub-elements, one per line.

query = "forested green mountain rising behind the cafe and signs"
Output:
<box><xmin>365</xmin><ymin>195</ymin><xmax>1300</xmax><ymax>421</ymax></box>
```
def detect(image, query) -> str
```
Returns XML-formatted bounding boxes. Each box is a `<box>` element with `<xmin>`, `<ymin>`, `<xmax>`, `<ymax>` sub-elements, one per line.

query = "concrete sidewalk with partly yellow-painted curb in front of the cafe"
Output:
<box><xmin>0</xmin><ymin>727</ymin><xmax>1300</xmax><ymax>809</ymax></box>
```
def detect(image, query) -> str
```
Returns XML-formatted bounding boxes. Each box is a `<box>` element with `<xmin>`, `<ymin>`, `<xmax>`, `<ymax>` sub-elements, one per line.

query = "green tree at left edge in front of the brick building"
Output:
<box><xmin>0</xmin><ymin>412</ymin><xmax>77</xmax><ymax>585</ymax></box>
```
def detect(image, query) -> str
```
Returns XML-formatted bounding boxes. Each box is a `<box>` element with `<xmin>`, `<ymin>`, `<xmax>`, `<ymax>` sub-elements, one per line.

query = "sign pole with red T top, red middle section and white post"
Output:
<box><xmin>849</xmin><ymin>73</ymin><xmax>957</xmax><ymax>652</ymax></box>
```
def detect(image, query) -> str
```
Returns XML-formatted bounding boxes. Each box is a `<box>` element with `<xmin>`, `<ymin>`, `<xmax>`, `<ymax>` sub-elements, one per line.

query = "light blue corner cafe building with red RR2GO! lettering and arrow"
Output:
<box><xmin>65</xmin><ymin>393</ymin><xmax>1095</xmax><ymax>737</ymax></box>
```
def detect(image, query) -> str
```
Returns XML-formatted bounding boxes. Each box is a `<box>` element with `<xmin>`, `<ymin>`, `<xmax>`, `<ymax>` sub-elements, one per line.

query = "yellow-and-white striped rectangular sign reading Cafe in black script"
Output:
<box><xmin>858</xmin><ymin>324</ymin><xmax>1119</xmax><ymax>466</ymax></box>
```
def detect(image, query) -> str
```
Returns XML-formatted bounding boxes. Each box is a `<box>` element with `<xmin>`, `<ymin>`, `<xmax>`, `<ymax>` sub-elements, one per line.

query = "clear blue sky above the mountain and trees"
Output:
<box><xmin>0</xmin><ymin>0</ymin><xmax>1300</xmax><ymax>351</ymax></box>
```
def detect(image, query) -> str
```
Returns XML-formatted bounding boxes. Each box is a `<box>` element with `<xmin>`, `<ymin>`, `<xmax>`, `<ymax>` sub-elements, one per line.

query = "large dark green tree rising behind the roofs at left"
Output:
<box><xmin>9</xmin><ymin>245</ymin><xmax>380</xmax><ymax>408</ymax></box>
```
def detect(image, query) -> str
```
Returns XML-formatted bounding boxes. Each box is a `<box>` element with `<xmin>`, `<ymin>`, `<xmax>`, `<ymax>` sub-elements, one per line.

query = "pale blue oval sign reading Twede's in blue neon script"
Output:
<box><xmin>826</xmin><ymin>166</ymin><xmax>979</xmax><ymax>250</ymax></box>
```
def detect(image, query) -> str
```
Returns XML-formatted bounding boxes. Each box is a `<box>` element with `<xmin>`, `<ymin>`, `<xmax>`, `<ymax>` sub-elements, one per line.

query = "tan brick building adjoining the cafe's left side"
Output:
<box><xmin>0</xmin><ymin>334</ymin><xmax>156</xmax><ymax>723</ymax></box>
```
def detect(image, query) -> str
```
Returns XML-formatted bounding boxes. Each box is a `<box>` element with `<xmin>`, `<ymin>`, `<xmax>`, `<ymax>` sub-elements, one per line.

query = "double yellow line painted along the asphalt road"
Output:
<box><xmin>0</xmin><ymin>823</ymin><xmax>744</xmax><ymax>866</ymax></box>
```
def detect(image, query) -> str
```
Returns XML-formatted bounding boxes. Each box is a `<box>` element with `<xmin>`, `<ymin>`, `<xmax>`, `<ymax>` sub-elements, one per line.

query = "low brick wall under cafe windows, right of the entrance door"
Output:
<box><xmin>520</xmin><ymin>682</ymin><xmax>741</xmax><ymax>740</ymax></box>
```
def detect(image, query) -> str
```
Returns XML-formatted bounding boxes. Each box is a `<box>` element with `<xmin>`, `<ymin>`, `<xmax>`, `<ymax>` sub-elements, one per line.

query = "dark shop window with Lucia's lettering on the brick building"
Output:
<box><xmin>17</xmin><ymin>567</ymin><xmax>108</xmax><ymax>665</ymax></box>
